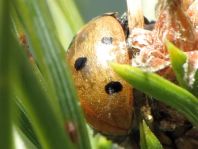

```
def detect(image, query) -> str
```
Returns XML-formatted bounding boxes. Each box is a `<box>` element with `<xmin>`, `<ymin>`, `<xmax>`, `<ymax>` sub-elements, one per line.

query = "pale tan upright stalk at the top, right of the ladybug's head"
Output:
<box><xmin>126</xmin><ymin>0</ymin><xmax>144</xmax><ymax>33</ymax></box>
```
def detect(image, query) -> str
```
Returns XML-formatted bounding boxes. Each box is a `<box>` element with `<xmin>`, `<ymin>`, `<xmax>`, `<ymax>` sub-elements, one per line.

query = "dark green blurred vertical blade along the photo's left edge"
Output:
<box><xmin>0</xmin><ymin>0</ymin><xmax>13</xmax><ymax>149</ymax></box>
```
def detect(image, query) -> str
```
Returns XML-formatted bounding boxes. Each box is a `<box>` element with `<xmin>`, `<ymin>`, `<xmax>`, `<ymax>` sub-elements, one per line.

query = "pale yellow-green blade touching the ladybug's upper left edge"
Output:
<box><xmin>48</xmin><ymin>0</ymin><xmax>83</xmax><ymax>50</ymax></box>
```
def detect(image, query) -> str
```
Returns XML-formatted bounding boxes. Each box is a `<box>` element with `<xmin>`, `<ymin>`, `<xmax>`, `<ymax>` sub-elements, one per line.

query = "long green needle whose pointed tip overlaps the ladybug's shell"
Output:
<box><xmin>111</xmin><ymin>63</ymin><xmax>198</xmax><ymax>126</ymax></box>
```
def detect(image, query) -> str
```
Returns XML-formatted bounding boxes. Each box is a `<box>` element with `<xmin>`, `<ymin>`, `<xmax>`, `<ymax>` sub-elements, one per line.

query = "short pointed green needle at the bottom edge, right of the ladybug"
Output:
<box><xmin>140</xmin><ymin>121</ymin><xmax>163</xmax><ymax>149</ymax></box>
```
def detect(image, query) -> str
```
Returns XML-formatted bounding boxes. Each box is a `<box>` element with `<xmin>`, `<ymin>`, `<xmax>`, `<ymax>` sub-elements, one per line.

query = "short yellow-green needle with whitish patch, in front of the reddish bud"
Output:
<box><xmin>166</xmin><ymin>41</ymin><xmax>198</xmax><ymax>96</ymax></box>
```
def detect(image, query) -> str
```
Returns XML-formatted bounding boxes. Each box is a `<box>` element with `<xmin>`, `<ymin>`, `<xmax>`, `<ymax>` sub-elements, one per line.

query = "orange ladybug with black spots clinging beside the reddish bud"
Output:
<box><xmin>67</xmin><ymin>13</ymin><xmax>133</xmax><ymax>136</ymax></box>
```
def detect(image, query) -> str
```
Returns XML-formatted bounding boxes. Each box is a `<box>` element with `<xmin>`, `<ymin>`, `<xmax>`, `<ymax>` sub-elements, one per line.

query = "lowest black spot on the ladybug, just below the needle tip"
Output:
<box><xmin>105</xmin><ymin>81</ymin><xmax>122</xmax><ymax>95</ymax></box>
